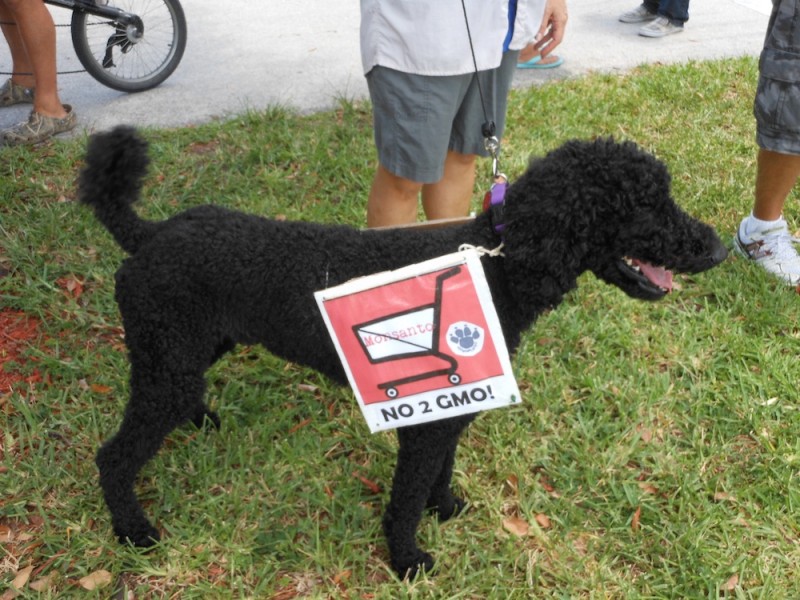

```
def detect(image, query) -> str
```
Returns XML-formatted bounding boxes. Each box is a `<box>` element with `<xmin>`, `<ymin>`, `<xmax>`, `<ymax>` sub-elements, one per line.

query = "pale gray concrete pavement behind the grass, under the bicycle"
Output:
<box><xmin>0</xmin><ymin>0</ymin><xmax>772</xmax><ymax>130</ymax></box>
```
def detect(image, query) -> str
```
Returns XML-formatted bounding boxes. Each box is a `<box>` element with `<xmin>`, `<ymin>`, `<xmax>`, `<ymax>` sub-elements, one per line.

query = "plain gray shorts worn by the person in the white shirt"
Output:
<box><xmin>367</xmin><ymin>51</ymin><xmax>519</xmax><ymax>183</ymax></box>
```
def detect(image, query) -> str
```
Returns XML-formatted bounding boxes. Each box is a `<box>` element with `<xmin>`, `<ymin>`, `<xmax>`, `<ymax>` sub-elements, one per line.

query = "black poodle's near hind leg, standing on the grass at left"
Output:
<box><xmin>96</xmin><ymin>368</ymin><xmax>205</xmax><ymax>547</ymax></box>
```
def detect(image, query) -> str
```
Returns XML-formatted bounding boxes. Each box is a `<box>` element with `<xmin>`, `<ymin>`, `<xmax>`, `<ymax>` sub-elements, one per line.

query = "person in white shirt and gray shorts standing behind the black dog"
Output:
<box><xmin>361</xmin><ymin>0</ymin><xmax>567</xmax><ymax>227</ymax></box>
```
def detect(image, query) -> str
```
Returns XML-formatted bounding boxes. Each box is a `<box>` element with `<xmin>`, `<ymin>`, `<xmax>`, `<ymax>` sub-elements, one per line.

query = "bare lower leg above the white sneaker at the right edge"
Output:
<box><xmin>753</xmin><ymin>148</ymin><xmax>800</xmax><ymax>221</ymax></box>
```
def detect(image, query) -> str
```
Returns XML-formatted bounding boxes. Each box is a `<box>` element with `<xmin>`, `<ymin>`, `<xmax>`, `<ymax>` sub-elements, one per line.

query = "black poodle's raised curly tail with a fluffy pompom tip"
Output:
<box><xmin>78</xmin><ymin>125</ymin><xmax>158</xmax><ymax>254</ymax></box>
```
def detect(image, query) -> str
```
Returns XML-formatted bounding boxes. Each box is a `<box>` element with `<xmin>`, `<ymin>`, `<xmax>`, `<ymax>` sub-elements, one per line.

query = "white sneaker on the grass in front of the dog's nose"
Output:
<box><xmin>733</xmin><ymin>218</ymin><xmax>800</xmax><ymax>285</ymax></box>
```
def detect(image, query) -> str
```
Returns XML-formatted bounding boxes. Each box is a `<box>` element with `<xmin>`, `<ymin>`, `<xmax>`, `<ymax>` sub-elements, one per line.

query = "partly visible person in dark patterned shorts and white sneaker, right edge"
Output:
<box><xmin>733</xmin><ymin>0</ymin><xmax>800</xmax><ymax>286</ymax></box>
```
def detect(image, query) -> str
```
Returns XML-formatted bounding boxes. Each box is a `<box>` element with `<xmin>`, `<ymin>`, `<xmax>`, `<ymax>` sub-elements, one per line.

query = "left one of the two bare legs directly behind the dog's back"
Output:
<box><xmin>367</xmin><ymin>165</ymin><xmax>422</xmax><ymax>227</ymax></box>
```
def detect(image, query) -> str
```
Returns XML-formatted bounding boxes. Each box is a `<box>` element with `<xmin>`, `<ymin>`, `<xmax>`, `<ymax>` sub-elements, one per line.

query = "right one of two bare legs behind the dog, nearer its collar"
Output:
<box><xmin>422</xmin><ymin>150</ymin><xmax>475</xmax><ymax>219</ymax></box>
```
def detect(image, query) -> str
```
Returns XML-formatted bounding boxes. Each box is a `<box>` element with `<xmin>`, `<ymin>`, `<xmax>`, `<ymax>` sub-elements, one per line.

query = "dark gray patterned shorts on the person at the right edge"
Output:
<box><xmin>753</xmin><ymin>0</ymin><xmax>800</xmax><ymax>154</ymax></box>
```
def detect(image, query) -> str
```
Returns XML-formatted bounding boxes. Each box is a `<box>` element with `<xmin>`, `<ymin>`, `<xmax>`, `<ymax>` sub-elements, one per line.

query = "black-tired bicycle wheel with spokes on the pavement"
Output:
<box><xmin>71</xmin><ymin>0</ymin><xmax>186</xmax><ymax>92</ymax></box>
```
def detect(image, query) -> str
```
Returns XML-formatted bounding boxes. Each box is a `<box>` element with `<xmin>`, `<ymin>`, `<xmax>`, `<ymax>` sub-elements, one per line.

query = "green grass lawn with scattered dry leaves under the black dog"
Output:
<box><xmin>0</xmin><ymin>59</ymin><xmax>800</xmax><ymax>600</ymax></box>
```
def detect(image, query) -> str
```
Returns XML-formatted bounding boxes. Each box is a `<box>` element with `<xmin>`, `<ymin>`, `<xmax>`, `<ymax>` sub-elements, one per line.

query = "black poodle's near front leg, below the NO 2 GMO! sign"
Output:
<box><xmin>383</xmin><ymin>419</ymin><xmax>466</xmax><ymax>578</ymax></box>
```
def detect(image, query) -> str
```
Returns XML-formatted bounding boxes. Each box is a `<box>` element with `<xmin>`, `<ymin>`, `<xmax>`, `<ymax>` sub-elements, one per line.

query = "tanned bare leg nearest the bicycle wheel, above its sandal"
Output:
<box><xmin>4</xmin><ymin>0</ymin><xmax>67</xmax><ymax>119</ymax></box>
